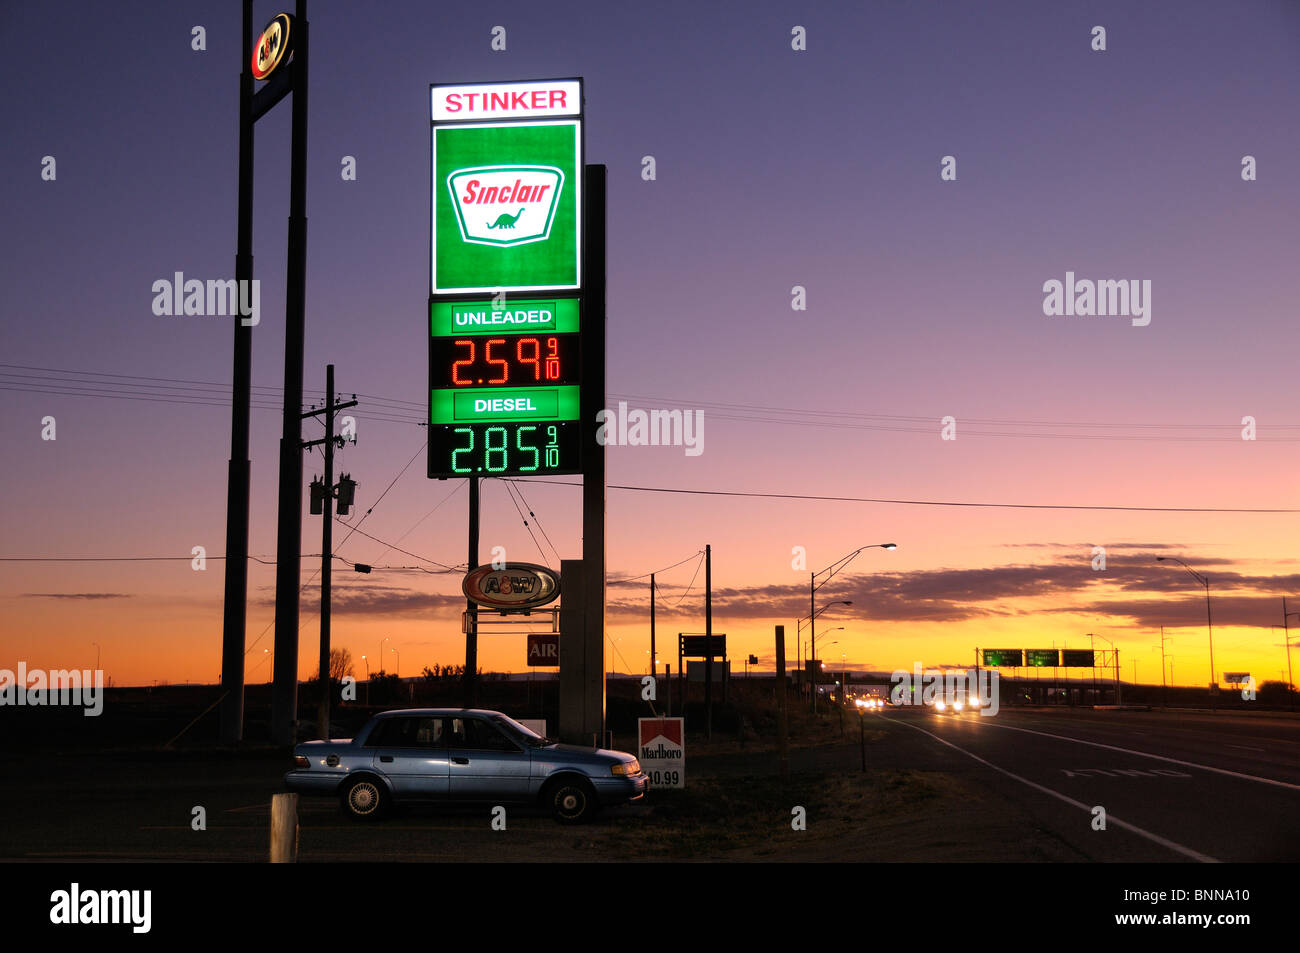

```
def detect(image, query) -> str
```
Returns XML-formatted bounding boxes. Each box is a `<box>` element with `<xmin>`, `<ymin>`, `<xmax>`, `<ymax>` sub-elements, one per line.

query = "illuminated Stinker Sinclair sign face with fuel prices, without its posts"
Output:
<box><xmin>428</xmin><ymin>79</ymin><xmax>582</xmax><ymax>478</ymax></box>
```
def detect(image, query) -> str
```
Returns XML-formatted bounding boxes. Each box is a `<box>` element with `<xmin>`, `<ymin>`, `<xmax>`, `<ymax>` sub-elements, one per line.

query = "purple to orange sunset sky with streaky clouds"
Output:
<box><xmin>0</xmin><ymin>0</ymin><xmax>1300</xmax><ymax>685</ymax></box>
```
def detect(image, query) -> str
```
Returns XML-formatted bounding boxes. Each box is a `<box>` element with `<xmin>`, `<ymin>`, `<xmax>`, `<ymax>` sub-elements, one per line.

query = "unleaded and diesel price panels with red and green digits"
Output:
<box><xmin>429</xmin><ymin>298</ymin><xmax>581</xmax><ymax>478</ymax></box>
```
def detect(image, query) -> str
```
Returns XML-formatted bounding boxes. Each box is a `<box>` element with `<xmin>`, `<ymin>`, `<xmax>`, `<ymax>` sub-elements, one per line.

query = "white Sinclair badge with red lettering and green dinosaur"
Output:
<box><xmin>447</xmin><ymin>165</ymin><xmax>564</xmax><ymax>248</ymax></box>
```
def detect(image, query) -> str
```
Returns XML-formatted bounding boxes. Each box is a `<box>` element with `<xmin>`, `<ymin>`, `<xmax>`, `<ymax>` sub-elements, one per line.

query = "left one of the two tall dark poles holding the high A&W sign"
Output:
<box><xmin>221</xmin><ymin>0</ymin><xmax>254</xmax><ymax>745</ymax></box>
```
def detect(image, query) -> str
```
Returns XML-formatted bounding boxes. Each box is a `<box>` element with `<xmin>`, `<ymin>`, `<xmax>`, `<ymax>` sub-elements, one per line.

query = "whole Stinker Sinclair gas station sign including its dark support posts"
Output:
<box><xmin>426</xmin><ymin>78</ymin><xmax>605</xmax><ymax>744</ymax></box>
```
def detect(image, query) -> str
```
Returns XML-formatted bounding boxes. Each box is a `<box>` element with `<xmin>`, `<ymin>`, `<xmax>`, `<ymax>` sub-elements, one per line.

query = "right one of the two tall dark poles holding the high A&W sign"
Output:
<box><xmin>270</xmin><ymin>0</ymin><xmax>308</xmax><ymax>745</ymax></box>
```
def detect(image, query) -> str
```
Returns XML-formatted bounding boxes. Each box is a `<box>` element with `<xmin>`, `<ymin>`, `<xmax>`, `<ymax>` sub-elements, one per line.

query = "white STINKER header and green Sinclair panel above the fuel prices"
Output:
<box><xmin>429</xmin><ymin>79</ymin><xmax>582</xmax><ymax>295</ymax></box>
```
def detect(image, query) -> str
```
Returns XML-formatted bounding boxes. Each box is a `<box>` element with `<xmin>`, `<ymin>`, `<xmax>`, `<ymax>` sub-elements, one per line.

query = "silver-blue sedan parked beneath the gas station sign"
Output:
<box><xmin>285</xmin><ymin>709</ymin><xmax>649</xmax><ymax>823</ymax></box>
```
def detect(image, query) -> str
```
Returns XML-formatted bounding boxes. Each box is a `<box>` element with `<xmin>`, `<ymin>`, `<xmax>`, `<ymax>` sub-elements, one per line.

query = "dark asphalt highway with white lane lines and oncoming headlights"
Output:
<box><xmin>875</xmin><ymin>709</ymin><xmax>1300</xmax><ymax>862</ymax></box>
